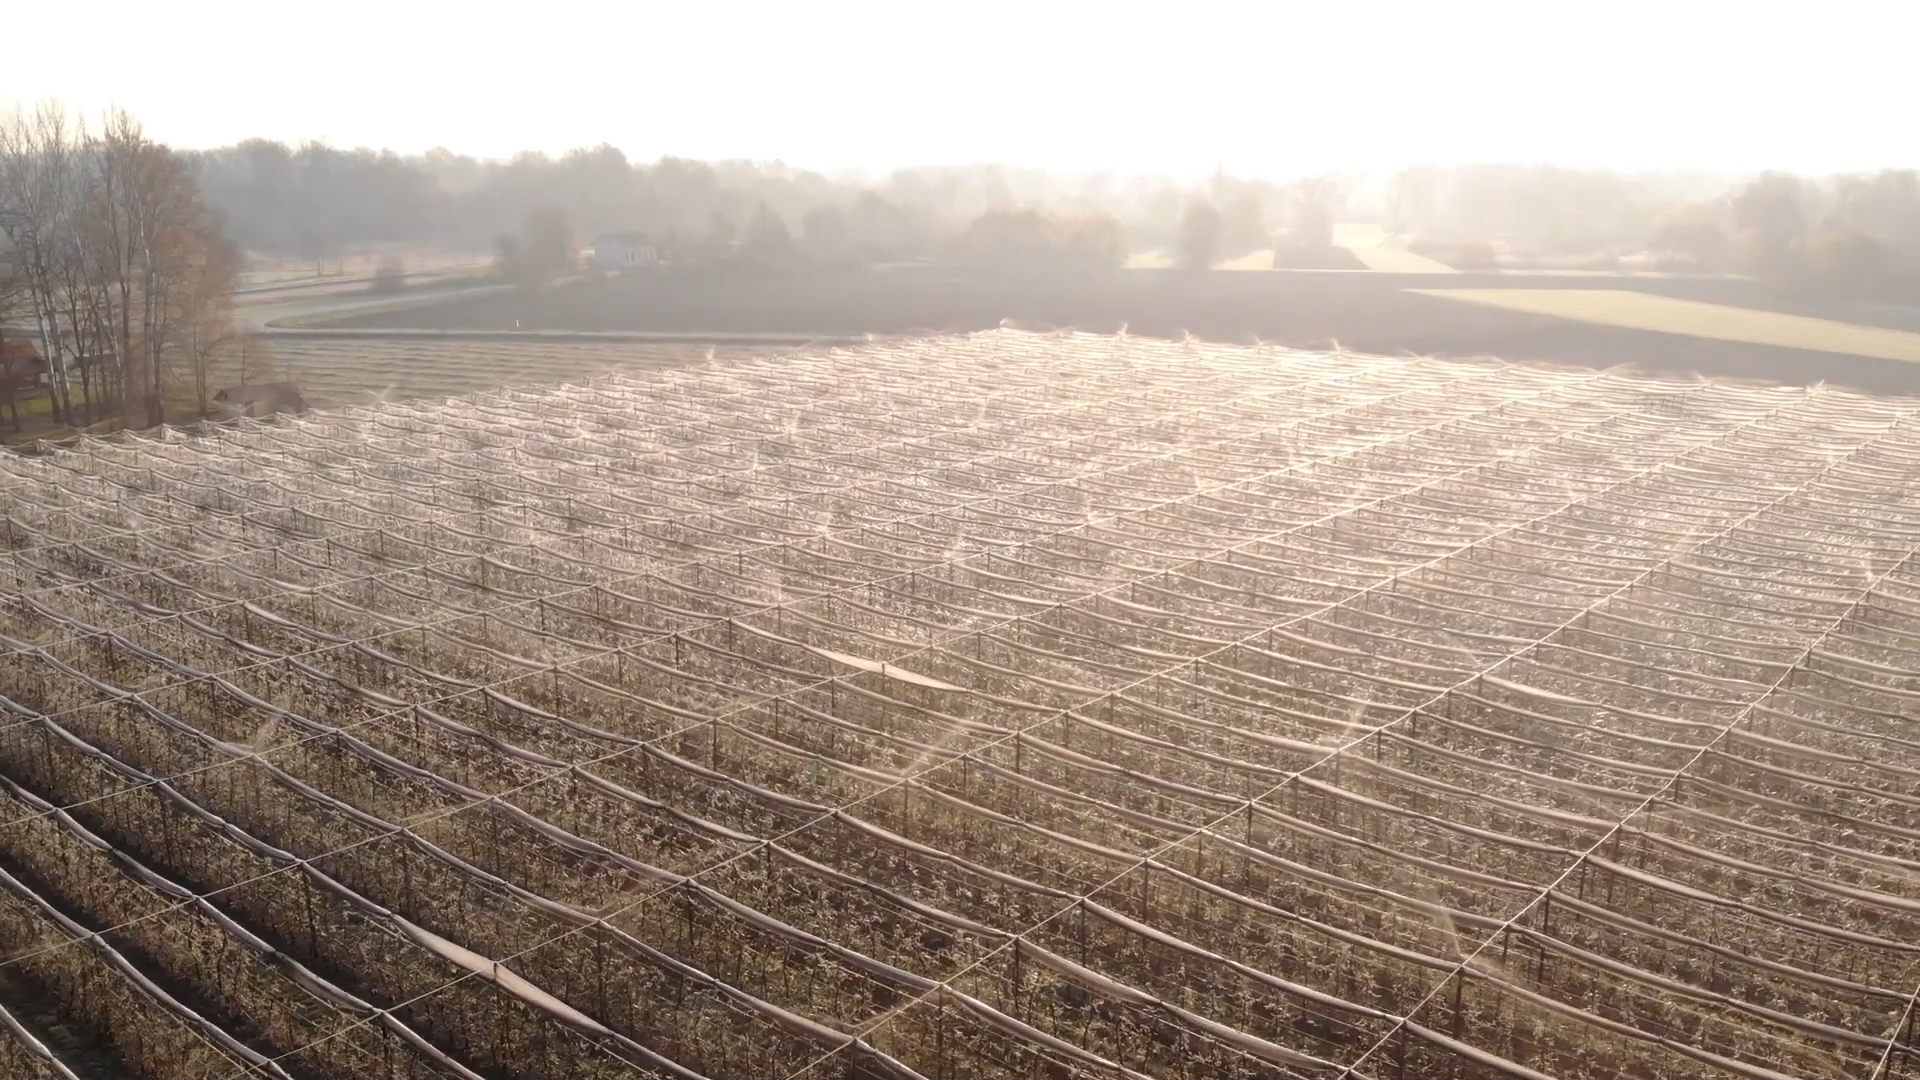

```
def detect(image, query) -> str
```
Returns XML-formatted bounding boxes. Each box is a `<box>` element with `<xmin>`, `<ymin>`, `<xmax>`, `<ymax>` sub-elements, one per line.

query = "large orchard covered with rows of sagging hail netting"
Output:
<box><xmin>0</xmin><ymin>331</ymin><xmax>1920</xmax><ymax>1078</ymax></box>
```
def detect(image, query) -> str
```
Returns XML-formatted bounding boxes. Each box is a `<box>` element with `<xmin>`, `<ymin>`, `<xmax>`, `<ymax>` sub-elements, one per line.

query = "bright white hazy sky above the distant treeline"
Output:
<box><xmin>0</xmin><ymin>0</ymin><xmax>1920</xmax><ymax>175</ymax></box>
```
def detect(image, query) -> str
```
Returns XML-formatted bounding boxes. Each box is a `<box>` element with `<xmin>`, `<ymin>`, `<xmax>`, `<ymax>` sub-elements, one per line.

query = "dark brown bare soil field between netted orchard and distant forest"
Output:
<box><xmin>314</xmin><ymin>269</ymin><xmax>1920</xmax><ymax>390</ymax></box>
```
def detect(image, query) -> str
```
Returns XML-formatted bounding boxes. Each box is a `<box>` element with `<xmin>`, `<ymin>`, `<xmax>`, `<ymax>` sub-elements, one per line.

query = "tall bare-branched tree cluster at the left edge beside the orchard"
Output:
<box><xmin>0</xmin><ymin>106</ymin><xmax>242</xmax><ymax>427</ymax></box>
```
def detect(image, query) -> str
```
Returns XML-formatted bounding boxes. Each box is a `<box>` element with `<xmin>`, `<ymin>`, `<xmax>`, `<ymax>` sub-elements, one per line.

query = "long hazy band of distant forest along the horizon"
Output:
<box><xmin>188</xmin><ymin>140</ymin><xmax>1920</xmax><ymax>288</ymax></box>
